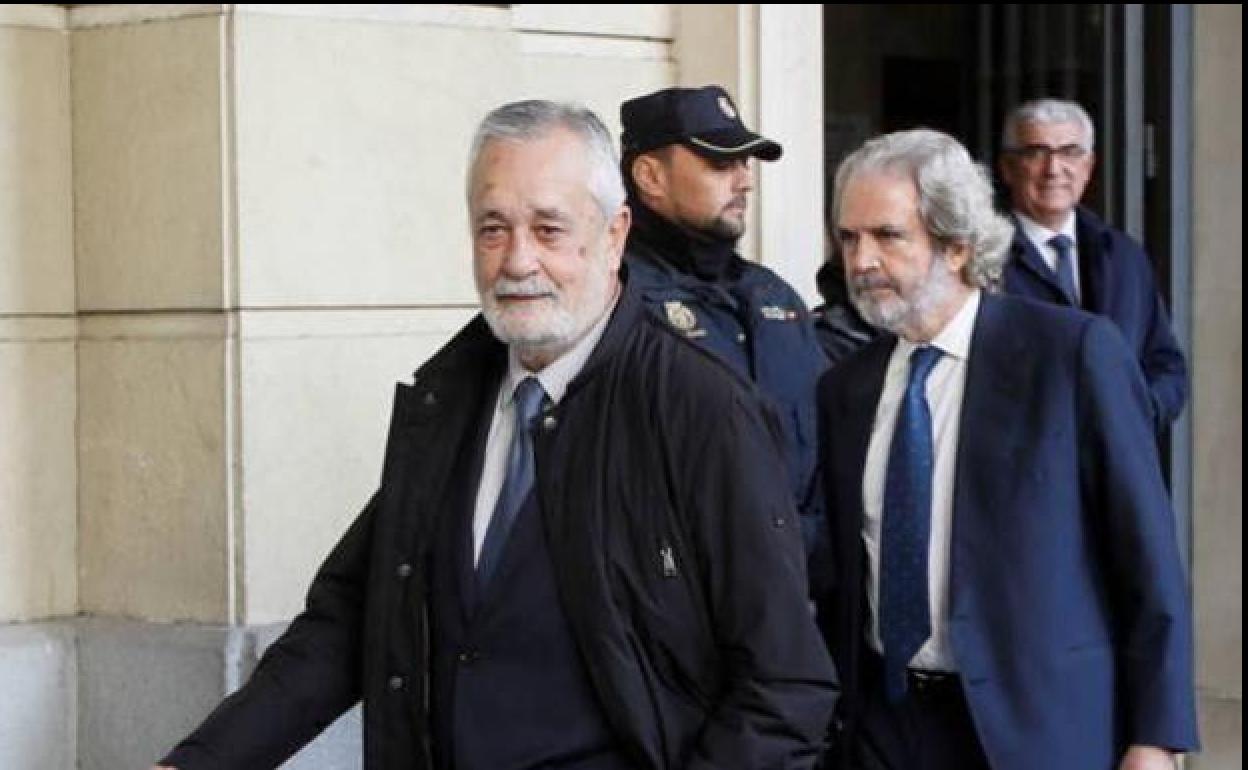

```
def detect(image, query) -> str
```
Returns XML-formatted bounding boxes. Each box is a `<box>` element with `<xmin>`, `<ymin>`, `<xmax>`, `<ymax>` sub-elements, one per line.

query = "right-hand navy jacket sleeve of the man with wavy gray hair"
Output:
<box><xmin>1080</xmin><ymin>319</ymin><xmax>1198</xmax><ymax>751</ymax></box>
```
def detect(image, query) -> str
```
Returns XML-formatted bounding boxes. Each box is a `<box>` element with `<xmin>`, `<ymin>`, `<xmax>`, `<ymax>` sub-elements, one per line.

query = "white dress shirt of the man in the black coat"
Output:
<box><xmin>472</xmin><ymin>303</ymin><xmax>615</xmax><ymax>565</ymax></box>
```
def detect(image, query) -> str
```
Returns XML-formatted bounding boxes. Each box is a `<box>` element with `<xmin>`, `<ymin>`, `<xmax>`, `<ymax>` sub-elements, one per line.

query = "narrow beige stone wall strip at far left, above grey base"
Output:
<box><xmin>0</xmin><ymin>5</ymin><xmax>77</xmax><ymax>623</ymax></box>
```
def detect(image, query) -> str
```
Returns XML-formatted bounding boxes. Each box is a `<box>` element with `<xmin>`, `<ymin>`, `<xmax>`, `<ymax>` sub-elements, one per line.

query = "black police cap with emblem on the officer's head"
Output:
<box><xmin>620</xmin><ymin>86</ymin><xmax>784</xmax><ymax>161</ymax></box>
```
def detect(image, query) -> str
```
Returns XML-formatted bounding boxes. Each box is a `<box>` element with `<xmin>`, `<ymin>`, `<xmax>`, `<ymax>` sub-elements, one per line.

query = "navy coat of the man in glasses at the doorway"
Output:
<box><xmin>1005</xmin><ymin>208</ymin><xmax>1188</xmax><ymax>432</ymax></box>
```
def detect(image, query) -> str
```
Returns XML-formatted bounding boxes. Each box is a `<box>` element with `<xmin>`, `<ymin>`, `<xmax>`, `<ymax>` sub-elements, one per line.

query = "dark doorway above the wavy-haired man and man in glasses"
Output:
<box><xmin>824</xmin><ymin>5</ymin><xmax>1121</xmax><ymax>209</ymax></box>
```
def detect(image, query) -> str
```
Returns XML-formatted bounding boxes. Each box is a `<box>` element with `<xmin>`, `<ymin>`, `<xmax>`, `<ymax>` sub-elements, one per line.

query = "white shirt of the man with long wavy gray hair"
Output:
<box><xmin>862</xmin><ymin>290</ymin><xmax>980</xmax><ymax>671</ymax></box>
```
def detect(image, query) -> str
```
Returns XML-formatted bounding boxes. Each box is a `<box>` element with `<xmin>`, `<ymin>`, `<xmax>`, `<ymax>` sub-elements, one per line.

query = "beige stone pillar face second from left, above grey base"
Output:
<box><xmin>71</xmin><ymin>6</ymin><xmax>236</xmax><ymax>623</ymax></box>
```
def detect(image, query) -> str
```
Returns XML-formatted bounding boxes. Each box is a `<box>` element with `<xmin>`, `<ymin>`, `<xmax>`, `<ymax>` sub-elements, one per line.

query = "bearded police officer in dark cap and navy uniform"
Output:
<box><xmin>620</xmin><ymin>86</ymin><xmax>826</xmax><ymax>551</ymax></box>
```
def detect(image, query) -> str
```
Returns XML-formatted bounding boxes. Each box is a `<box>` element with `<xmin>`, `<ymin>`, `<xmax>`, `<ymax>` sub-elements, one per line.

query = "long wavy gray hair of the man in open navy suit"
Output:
<box><xmin>832</xmin><ymin>129</ymin><xmax>1013</xmax><ymax>290</ymax></box>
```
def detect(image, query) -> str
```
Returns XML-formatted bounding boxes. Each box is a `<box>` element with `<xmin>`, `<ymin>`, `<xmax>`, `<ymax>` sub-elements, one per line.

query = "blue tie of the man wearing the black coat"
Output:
<box><xmin>477</xmin><ymin>377</ymin><xmax>545</xmax><ymax>585</ymax></box>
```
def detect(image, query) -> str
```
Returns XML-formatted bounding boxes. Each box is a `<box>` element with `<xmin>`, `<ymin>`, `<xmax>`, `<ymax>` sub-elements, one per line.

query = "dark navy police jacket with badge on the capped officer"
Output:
<box><xmin>625</xmin><ymin>198</ymin><xmax>827</xmax><ymax>540</ymax></box>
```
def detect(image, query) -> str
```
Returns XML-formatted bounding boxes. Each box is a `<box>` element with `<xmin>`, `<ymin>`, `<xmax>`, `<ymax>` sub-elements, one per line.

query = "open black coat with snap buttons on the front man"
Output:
<box><xmin>158</xmin><ymin>270</ymin><xmax>836</xmax><ymax>770</ymax></box>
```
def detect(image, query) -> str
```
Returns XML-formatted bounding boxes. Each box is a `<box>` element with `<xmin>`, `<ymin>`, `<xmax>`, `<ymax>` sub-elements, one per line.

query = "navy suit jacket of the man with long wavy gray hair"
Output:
<box><xmin>819</xmin><ymin>295</ymin><xmax>1197</xmax><ymax>770</ymax></box>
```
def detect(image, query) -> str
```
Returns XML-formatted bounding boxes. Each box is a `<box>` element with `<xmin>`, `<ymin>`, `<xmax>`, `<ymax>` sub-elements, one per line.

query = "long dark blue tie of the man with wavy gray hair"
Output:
<box><xmin>880</xmin><ymin>347</ymin><xmax>941</xmax><ymax>701</ymax></box>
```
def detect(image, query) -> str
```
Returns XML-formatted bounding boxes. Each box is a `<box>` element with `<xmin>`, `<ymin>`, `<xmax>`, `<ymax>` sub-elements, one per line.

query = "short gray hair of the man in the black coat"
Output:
<box><xmin>468</xmin><ymin>100</ymin><xmax>624</xmax><ymax>220</ymax></box>
